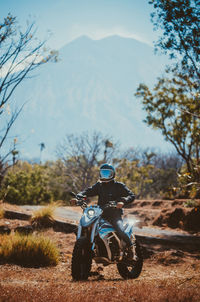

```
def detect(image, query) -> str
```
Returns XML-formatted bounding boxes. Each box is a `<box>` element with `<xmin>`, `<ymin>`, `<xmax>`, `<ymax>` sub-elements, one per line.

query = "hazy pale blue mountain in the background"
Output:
<box><xmin>13</xmin><ymin>36</ymin><xmax>169</xmax><ymax>159</ymax></box>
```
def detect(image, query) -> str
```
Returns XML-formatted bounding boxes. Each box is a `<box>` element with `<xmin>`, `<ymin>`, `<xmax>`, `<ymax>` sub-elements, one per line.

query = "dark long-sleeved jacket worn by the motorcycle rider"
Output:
<box><xmin>79</xmin><ymin>180</ymin><xmax>135</xmax><ymax>207</ymax></box>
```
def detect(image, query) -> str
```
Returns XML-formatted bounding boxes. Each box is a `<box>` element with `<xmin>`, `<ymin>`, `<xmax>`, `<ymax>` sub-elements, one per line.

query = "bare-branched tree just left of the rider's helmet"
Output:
<box><xmin>57</xmin><ymin>132</ymin><xmax>115</xmax><ymax>190</ymax></box>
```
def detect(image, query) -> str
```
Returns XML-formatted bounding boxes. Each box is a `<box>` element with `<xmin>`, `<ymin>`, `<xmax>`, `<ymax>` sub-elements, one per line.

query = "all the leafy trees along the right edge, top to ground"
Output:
<box><xmin>136</xmin><ymin>0</ymin><xmax>200</xmax><ymax>198</ymax></box>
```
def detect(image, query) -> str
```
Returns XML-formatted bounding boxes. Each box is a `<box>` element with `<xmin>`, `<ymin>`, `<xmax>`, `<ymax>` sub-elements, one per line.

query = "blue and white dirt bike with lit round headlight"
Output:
<box><xmin>71</xmin><ymin>193</ymin><xmax>143</xmax><ymax>281</ymax></box>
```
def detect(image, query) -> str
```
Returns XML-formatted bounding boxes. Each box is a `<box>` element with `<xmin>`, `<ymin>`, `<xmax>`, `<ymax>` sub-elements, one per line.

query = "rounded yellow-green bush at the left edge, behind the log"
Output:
<box><xmin>1</xmin><ymin>162</ymin><xmax>53</xmax><ymax>205</ymax></box>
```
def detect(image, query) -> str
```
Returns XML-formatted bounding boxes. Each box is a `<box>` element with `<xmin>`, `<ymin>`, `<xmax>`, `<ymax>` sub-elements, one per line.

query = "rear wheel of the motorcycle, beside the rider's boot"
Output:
<box><xmin>117</xmin><ymin>241</ymin><xmax>143</xmax><ymax>279</ymax></box>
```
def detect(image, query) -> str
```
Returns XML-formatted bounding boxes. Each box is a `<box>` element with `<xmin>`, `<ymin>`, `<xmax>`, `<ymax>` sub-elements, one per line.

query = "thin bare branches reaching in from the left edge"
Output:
<box><xmin>0</xmin><ymin>15</ymin><xmax>57</xmax><ymax>185</ymax></box>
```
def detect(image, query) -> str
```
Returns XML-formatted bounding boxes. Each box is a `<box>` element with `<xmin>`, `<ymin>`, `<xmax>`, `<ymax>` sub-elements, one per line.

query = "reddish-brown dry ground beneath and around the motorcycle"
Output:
<box><xmin>0</xmin><ymin>204</ymin><xmax>200</xmax><ymax>302</ymax></box>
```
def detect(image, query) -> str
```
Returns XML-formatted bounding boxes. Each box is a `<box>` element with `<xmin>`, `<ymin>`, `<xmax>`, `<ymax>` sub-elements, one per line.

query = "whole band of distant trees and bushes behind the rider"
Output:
<box><xmin>0</xmin><ymin>133</ymin><xmax>190</xmax><ymax>205</ymax></box>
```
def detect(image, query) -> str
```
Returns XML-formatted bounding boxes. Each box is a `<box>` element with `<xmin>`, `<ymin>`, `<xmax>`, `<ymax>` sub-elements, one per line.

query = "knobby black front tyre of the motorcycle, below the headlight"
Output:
<box><xmin>71</xmin><ymin>237</ymin><xmax>92</xmax><ymax>281</ymax></box>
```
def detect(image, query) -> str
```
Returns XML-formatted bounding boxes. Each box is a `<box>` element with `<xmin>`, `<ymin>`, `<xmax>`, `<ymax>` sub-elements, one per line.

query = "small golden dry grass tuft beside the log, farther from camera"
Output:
<box><xmin>31</xmin><ymin>204</ymin><xmax>56</xmax><ymax>229</ymax></box>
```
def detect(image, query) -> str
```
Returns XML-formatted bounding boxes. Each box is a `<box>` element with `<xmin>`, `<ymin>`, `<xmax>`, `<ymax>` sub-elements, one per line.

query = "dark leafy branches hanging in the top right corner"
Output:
<box><xmin>149</xmin><ymin>0</ymin><xmax>200</xmax><ymax>81</ymax></box>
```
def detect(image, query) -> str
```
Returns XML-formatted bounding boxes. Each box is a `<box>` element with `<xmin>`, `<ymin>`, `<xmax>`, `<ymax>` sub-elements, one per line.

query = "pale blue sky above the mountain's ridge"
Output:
<box><xmin>0</xmin><ymin>0</ymin><xmax>156</xmax><ymax>49</ymax></box>
